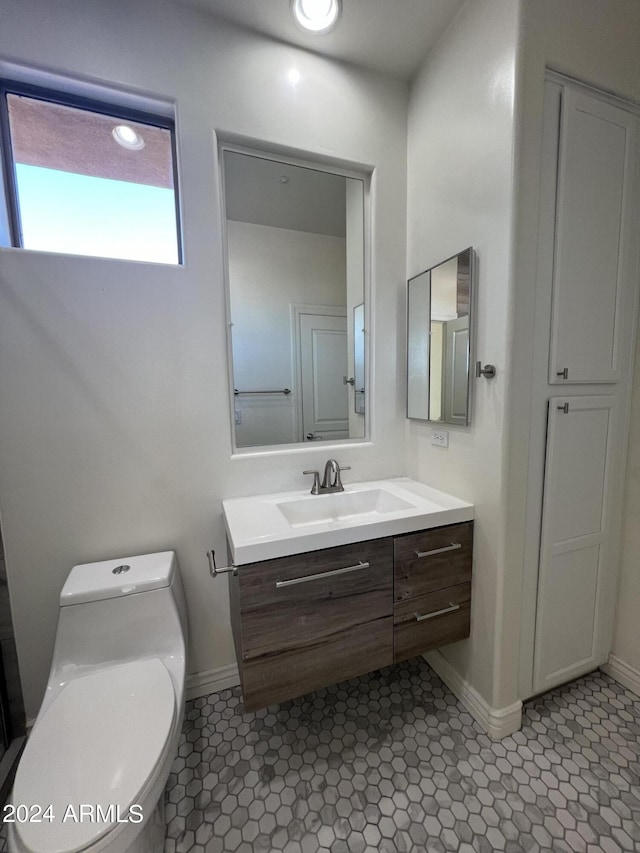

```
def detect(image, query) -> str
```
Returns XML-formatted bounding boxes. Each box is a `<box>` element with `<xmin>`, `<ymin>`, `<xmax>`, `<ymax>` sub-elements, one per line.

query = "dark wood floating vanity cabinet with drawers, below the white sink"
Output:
<box><xmin>230</xmin><ymin>522</ymin><xmax>473</xmax><ymax>711</ymax></box>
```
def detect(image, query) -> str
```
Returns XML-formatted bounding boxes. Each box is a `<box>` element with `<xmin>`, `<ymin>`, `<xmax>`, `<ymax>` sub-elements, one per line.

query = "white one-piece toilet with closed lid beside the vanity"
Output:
<box><xmin>5</xmin><ymin>551</ymin><xmax>187</xmax><ymax>853</ymax></box>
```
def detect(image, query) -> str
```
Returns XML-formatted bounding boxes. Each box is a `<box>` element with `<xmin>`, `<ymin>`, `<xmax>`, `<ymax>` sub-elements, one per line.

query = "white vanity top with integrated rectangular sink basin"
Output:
<box><xmin>222</xmin><ymin>477</ymin><xmax>474</xmax><ymax>566</ymax></box>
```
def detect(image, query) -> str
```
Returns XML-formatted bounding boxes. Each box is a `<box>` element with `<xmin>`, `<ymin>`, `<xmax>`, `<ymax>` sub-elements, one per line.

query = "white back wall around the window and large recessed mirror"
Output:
<box><xmin>0</xmin><ymin>0</ymin><xmax>408</xmax><ymax>717</ymax></box>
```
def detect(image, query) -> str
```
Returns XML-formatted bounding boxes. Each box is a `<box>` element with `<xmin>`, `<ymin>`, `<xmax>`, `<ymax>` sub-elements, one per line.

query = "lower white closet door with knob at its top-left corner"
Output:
<box><xmin>534</xmin><ymin>395</ymin><xmax>616</xmax><ymax>692</ymax></box>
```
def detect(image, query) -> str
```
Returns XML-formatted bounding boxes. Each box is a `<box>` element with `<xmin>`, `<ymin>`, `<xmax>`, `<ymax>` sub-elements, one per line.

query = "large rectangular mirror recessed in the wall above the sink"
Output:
<box><xmin>222</xmin><ymin>148</ymin><xmax>365</xmax><ymax>447</ymax></box>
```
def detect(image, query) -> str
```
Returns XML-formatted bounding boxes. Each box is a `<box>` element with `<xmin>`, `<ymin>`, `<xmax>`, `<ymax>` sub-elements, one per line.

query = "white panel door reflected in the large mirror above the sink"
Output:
<box><xmin>300</xmin><ymin>314</ymin><xmax>349</xmax><ymax>441</ymax></box>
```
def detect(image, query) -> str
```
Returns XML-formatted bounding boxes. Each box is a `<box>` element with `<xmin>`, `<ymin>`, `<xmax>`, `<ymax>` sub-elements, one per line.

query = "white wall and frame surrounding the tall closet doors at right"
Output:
<box><xmin>502</xmin><ymin>0</ymin><xmax>640</xmax><ymax>695</ymax></box>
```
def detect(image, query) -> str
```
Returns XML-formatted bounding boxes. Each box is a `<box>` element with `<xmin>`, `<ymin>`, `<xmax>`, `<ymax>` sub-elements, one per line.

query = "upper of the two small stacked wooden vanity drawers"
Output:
<box><xmin>394</xmin><ymin>521</ymin><xmax>473</xmax><ymax>601</ymax></box>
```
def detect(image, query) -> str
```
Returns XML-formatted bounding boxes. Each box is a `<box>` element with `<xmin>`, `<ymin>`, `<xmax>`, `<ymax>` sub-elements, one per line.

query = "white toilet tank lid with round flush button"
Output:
<box><xmin>60</xmin><ymin>551</ymin><xmax>177</xmax><ymax>607</ymax></box>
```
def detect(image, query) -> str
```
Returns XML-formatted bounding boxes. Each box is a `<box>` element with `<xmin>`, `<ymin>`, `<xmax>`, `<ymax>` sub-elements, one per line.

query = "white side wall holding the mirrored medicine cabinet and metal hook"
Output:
<box><xmin>406</xmin><ymin>0</ymin><xmax>518</xmax><ymax>707</ymax></box>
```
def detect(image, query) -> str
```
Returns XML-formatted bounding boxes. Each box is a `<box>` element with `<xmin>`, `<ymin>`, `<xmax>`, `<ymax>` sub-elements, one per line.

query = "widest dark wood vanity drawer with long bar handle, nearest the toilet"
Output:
<box><xmin>237</xmin><ymin>539</ymin><xmax>393</xmax><ymax>672</ymax></box>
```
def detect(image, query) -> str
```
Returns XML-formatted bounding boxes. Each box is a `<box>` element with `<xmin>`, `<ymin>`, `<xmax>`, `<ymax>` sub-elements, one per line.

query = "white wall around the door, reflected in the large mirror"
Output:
<box><xmin>227</xmin><ymin>221</ymin><xmax>344</xmax><ymax>447</ymax></box>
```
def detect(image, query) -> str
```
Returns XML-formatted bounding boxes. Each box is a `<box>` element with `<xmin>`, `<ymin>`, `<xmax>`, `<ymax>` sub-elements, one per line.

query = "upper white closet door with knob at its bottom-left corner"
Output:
<box><xmin>549</xmin><ymin>87</ymin><xmax>637</xmax><ymax>384</ymax></box>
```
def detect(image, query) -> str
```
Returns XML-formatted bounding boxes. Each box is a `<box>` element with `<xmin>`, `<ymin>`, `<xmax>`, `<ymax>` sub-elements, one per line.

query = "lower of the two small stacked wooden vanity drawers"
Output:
<box><xmin>393</xmin><ymin>583</ymin><xmax>471</xmax><ymax>661</ymax></box>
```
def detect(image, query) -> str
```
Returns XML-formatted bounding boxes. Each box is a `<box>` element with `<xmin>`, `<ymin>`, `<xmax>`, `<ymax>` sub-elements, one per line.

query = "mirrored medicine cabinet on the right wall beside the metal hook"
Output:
<box><xmin>407</xmin><ymin>248</ymin><xmax>474</xmax><ymax>426</ymax></box>
